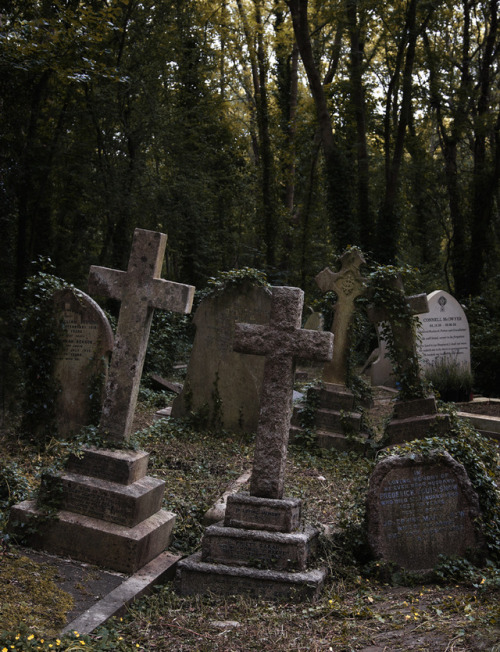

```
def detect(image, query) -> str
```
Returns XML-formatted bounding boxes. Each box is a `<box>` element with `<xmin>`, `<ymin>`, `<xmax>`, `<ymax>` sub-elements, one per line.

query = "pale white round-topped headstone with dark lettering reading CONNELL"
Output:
<box><xmin>418</xmin><ymin>290</ymin><xmax>470</xmax><ymax>371</ymax></box>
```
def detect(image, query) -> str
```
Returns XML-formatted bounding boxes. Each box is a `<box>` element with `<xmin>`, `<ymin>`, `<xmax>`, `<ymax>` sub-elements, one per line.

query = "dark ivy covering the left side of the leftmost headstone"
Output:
<box><xmin>19</xmin><ymin>259</ymin><xmax>68</xmax><ymax>441</ymax></box>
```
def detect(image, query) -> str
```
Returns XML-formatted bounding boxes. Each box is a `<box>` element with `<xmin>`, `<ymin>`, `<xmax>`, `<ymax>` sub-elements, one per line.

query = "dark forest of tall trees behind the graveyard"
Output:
<box><xmin>0</xmin><ymin>0</ymin><xmax>500</xmax><ymax>395</ymax></box>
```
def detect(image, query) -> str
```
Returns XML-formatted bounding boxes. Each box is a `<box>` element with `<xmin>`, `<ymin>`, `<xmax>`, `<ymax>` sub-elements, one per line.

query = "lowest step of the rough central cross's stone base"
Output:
<box><xmin>176</xmin><ymin>552</ymin><xmax>326</xmax><ymax>600</ymax></box>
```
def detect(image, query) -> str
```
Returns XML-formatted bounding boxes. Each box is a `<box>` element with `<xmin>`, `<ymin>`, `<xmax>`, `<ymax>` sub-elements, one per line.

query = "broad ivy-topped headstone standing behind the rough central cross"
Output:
<box><xmin>172</xmin><ymin>280</ymin><xmax>271</xmax><ymax>432</ymax></box>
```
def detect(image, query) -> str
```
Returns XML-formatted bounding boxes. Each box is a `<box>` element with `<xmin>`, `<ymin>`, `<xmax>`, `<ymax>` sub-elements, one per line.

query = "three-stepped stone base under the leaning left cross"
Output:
<box><xmin>9</xmin><ymin>448</ymin><xmax>175</xmax><ymax>573</ymax></box>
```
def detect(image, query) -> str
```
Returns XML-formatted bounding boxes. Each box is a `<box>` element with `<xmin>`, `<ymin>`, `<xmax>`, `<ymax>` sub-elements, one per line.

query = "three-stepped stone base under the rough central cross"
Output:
<box><xmin>176</xmin><ymin>493</ymin><xmax>326</xmax><ymax>599</ymax></box>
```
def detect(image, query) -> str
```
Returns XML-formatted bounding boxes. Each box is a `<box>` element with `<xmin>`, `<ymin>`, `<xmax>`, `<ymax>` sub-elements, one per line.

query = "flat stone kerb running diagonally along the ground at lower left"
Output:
<box><xmin>61</xmin><ymin>551</ymin><xmax>181</xmax><ymax>634</ymax></box>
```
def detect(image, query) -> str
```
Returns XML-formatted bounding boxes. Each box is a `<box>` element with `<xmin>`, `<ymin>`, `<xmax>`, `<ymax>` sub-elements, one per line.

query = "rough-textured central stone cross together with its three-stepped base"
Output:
<box><xmin>177</xmin><ymin>287</ymin><xmax>333</xmax><ymax>599</ymax></box>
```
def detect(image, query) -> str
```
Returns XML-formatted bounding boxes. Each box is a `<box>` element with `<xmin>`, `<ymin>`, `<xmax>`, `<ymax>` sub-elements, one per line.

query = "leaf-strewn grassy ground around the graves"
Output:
<box><xmin>0</xmin><ymin>396</ymin><xmax>500</xmax><ymax>652</ymax></box>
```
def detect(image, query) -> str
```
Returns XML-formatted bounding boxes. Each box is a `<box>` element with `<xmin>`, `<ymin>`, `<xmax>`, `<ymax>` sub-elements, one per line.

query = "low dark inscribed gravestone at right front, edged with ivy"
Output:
<box><xmin>367</xmin><ymin>452</ymin><xmax>481</xmax><ymax>571</ymax></box>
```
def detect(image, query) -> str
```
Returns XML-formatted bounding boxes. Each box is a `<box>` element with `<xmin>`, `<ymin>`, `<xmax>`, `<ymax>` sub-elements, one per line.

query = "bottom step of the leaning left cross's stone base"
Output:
<box><xmin>9</xmin><ymin>501</ymin><xmax>175</xmax><ymax>574</ymax></box>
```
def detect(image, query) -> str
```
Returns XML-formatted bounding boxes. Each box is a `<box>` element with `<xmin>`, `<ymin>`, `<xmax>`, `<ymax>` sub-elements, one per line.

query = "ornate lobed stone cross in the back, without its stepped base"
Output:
<box><xmin>316</xmin><ymin>249</ymin><xmax>366</xmax><ymax>385</ymax></box>
